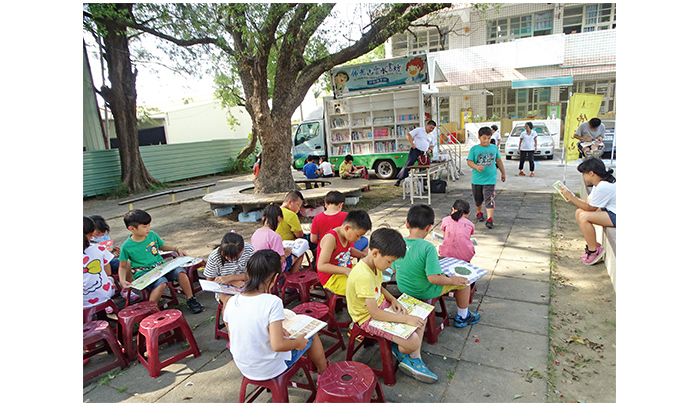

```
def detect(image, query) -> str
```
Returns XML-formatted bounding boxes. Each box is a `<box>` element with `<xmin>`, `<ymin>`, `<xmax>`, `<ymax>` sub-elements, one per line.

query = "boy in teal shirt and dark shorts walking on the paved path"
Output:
<box><xmin>467</xmin><ymin>127</ymin><xmax>506</xmax><ymax>228</ymax></box>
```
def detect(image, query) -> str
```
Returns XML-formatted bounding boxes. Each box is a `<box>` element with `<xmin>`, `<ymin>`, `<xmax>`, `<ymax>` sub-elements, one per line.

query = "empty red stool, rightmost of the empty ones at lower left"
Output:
<box><xmin>137</xmin><ymin>309</ymin><xmax>202</xmax><ymax>378</ymax></box>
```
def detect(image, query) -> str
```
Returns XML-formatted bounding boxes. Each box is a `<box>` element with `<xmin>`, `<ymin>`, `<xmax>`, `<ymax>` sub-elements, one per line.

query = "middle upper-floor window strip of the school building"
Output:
<box><xmin>486</xmin><ymin>10</ymin><xmax>553</xmax><ymax>44</ymax></box>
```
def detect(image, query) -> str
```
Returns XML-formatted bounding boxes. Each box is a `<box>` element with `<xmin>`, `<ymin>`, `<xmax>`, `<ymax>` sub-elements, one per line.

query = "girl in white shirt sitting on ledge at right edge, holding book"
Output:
<box><xmin>560</xmin><ymin>158</ymin><xmax>617</xmax><ymax>265</ymax></box>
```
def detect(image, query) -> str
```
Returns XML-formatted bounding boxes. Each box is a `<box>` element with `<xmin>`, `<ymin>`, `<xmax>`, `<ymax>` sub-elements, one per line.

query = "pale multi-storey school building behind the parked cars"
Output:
<box><xmin>386</xmin><ymin>3</ymin><xmax>616</xmax><ymax>128</ymax></box>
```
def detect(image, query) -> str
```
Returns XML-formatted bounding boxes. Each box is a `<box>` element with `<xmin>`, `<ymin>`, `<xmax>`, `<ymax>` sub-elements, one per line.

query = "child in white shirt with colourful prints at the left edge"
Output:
<box><xmin>83</xmin><ymin>217</ymin><xmax>118</xmax><ymax>312</ymax></box>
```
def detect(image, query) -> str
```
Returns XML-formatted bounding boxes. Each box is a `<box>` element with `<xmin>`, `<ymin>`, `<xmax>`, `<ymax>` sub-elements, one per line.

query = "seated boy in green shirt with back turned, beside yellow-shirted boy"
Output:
<box><xmin>394</xmin><ymin>204</ymin><xmax>480</xmax><ymax>328</ymax></box>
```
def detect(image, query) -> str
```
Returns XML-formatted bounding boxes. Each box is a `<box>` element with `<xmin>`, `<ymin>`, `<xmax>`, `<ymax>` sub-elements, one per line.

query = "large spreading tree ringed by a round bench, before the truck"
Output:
<box><xmin>119</xmin><ymin>3</ymin><xmax>456</xmax><ymax>193</ymax></box>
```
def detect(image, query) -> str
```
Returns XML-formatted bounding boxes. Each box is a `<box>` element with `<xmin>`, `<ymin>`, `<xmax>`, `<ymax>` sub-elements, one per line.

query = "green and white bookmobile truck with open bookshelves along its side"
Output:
<box><xmin>292</xmin><ymin>54</ymin><xmax>446</xmax><ymax>179</ymax></box>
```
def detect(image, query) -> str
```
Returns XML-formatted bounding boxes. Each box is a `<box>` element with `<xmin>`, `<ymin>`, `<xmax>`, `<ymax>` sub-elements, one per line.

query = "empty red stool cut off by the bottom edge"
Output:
<box><xmin>314</xmin><ymin>361</ymin><xmax>386</xmax><ymax>403</ymax></box>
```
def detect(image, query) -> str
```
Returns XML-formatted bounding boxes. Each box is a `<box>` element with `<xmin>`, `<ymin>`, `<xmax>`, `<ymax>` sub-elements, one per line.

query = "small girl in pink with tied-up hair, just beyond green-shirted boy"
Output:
<box><xmin>438</xmin><ymin>199</ymin><xmax>475</xmax><ymax>262</ymax></box>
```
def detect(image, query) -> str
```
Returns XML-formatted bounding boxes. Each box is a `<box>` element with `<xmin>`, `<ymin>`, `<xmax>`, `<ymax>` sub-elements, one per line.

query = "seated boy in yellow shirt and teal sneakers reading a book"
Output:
<box><xmin>346</xmin><ymin>228</ymin><xmax>438</xmax><ymax>383</ymax></box>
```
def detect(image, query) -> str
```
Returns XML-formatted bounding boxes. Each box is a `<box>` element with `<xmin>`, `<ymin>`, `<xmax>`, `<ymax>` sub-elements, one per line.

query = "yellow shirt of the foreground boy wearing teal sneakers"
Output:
<box><xmin>345</xmin><ymin>260</ymin><xmax>384</xmax><ymax>324</ymax></box>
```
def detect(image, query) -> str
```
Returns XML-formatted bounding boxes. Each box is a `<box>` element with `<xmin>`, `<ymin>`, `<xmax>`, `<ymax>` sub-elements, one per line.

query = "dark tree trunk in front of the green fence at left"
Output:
<box><xmin>102</xmin><ymin>4</ymin><xmax>160</xmax><ymax>193</ymax></box>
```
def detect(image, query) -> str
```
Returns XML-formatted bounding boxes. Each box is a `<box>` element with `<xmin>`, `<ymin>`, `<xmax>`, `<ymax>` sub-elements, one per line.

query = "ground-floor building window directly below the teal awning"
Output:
<box><xmin>486</xmin><ymin>87</ymin><xmax>551</xmax><ymax>118</ymax></box>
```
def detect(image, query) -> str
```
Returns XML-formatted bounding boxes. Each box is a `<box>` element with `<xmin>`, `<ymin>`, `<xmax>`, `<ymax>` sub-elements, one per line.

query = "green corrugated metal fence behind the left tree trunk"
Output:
<box><xmin>83</xmin><ymin>139</ymin><xmax>248</xmax><ymax>196</ymax></box>
